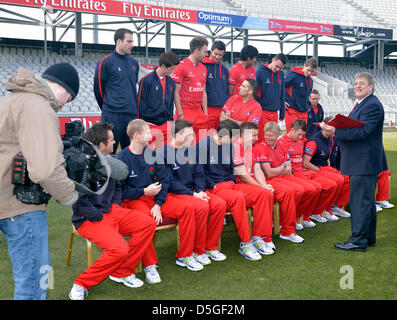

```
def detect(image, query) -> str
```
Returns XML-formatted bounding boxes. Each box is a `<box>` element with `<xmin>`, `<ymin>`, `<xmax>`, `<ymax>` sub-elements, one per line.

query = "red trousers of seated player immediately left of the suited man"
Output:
<box><xmin>316</xmin><ymin>166</ymin><xmax>350</xmax><ymax>211</ymax></box>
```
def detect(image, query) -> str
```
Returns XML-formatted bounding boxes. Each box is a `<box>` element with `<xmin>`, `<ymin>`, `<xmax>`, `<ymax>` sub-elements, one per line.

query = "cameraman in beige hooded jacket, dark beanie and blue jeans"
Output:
<box><xmin>0</xmin><ymin>63</ymin><xmax>79</xmax><ymax>300</ymax></box>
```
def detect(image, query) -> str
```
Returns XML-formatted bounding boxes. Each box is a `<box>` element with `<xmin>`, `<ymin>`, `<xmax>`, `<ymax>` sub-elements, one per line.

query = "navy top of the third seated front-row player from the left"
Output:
<box><xmin>157</xmin><ymin>144</ymin><xmax>206</xmax><ymax>196</ymax></box>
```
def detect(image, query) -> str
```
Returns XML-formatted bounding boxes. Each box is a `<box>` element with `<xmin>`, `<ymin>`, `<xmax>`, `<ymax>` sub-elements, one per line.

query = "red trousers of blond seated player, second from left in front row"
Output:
<box><xmin>122</xmin><ymin>196</ymin><xmax>195</xmax><ymax>260</ymax></box>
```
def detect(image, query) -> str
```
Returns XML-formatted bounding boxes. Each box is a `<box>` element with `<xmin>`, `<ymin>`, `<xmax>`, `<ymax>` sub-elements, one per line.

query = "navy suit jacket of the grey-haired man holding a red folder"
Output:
<box><xmin>335</xmin><ymin>94</ymin><xmax>385</xmax><ymax>175</ymax></box>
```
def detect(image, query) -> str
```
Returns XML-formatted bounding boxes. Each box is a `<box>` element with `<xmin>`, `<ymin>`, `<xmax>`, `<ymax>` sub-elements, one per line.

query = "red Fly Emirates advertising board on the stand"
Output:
<box><xmin>7</xmin><ymin>0</ymin><xmax>197</xmax><ymax>23</ymax></box>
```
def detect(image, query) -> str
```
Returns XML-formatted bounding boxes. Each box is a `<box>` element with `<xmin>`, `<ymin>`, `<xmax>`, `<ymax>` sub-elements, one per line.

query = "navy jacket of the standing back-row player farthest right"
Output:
<box><xmin>285</xmin><ymin>68</ymin><xmax>313</xmax><ymax>112</ymax></box>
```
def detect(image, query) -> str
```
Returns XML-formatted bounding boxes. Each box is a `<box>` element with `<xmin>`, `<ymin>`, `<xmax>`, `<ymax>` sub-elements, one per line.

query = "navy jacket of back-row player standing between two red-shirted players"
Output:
<box><xmin>203</xmin><ymin>56</ymin><xmax>229</xmax><ymax>107</ymax></box>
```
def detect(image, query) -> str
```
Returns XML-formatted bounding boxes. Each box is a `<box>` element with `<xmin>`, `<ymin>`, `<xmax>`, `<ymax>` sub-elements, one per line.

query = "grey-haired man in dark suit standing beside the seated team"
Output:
<box><xmin>321</xmin><ymin>72</ymin><xmax>384</xmax><ymax>251</ymax></box>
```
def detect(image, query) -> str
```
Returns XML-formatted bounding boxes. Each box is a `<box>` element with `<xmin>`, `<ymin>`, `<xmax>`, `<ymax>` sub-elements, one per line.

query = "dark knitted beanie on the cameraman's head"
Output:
<box><xmin>42</xmin><ymin>62</ymin><xmax>80</xmax><ymax>100</ymax></box>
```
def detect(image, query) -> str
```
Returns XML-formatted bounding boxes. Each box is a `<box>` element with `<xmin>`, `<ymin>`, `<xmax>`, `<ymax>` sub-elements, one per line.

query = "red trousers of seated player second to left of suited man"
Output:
<box><xmin>294</xmin><ymin>170</ymin><xmax>338</xmax><ymax>216</ymax></box>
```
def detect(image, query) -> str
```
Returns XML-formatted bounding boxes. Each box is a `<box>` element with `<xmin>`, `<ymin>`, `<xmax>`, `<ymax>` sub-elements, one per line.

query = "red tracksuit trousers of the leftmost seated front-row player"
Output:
<box><xmin>74</xmin><ymin>204</ymin><xmax>156</xmax><ymax>290</ymax></box>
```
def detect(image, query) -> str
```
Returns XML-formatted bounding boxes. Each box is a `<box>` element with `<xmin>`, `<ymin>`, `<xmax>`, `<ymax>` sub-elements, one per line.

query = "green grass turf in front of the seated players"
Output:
<box><xmin>0</xmin><ymin>131</ymin><xmax>397</xmax><ymax>300</ymax></box>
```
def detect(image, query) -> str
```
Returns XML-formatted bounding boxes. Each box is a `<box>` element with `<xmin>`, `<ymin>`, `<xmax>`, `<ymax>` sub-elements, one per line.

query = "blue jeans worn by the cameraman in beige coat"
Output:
<box><xmin>0</xmin><ymin>211</ymin><xmax>51</xmax><ymax>300</ymax></box>
